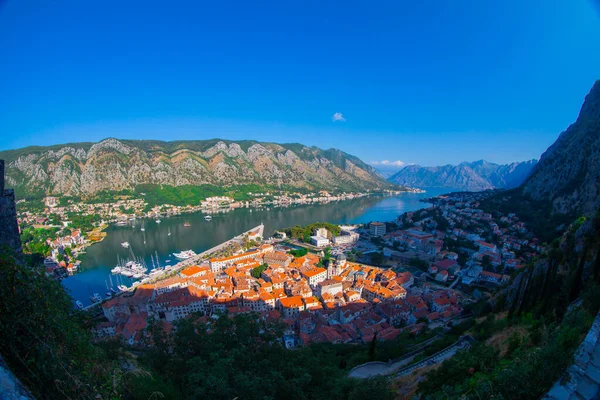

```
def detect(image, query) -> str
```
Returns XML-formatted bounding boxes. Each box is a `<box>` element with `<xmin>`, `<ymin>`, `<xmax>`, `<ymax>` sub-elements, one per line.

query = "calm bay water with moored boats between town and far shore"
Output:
<box><xmin>63</xmin><ymin>189</ymin><xmax>445</xmax><ymax>305</ymax></box>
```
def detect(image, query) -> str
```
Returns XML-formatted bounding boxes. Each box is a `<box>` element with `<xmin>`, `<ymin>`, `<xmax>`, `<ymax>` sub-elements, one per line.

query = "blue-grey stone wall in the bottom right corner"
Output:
<box><xmin>544</xmin><ymin>313</ymin><xmax>600</xmax><ymax>400</ymax></box>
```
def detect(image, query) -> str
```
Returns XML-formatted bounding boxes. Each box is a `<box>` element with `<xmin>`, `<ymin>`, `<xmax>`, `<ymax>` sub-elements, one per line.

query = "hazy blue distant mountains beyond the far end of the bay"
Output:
<box><xmin>387</xmin><ymin>160</ymin><xmax>536</xmax><ymax>191</ymax></box>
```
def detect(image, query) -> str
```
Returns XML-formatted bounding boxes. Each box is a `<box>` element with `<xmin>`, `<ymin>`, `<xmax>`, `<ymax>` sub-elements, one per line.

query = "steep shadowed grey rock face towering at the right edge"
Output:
<box><xmin>523</xmin><ymin>81</ymin><xmax>600</xmax><ymax>214</ymax></box>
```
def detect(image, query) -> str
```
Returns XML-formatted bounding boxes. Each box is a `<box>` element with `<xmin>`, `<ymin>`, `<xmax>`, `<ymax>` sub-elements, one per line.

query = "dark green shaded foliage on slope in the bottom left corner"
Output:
<box><xmin>0</xmin><ymin>253</ymin><xmax>120</xmax><ymax>399</ymax></box>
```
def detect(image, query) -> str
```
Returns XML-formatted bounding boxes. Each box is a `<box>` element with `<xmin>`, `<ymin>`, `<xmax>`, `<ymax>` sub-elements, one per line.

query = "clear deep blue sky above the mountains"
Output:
<box><xmin>0</xmin><ymin>0</ymin><xmax>600</xmax><ymax>165</ymax></box>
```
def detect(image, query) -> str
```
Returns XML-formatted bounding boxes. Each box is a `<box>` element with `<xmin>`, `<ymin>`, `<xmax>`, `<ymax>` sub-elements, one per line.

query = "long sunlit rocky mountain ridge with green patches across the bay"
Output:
<box><xmin>0</xmin><ymin>138</ymin><xmax>394</xmax><ymax>196</ymax></box>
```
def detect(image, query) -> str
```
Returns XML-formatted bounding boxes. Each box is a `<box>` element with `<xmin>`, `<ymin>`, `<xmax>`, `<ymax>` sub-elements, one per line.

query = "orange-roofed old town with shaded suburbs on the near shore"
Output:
<box><xmin>89</xmin><ymin>189</ymin><xmax>542</xmax><ymax>348</ymax></box>
